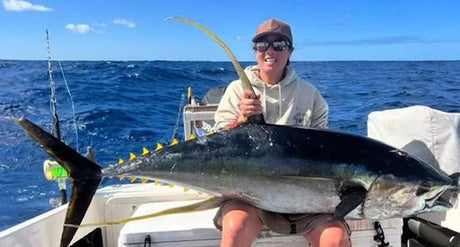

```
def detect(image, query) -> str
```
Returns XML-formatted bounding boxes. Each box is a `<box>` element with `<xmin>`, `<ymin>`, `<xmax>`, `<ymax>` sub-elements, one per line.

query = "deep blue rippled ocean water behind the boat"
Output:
<box><xmin>0</xmin><ymin>60</ymin><xmax>460</xmax><ymax>230</ymax></box>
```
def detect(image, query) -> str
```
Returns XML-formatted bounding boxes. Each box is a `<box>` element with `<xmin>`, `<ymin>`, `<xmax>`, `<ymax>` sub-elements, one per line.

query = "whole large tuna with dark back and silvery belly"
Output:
<box><xmin>15</xmin><ymin>119</ymin><xmax>458</xmax><ymax>246</ymax></box>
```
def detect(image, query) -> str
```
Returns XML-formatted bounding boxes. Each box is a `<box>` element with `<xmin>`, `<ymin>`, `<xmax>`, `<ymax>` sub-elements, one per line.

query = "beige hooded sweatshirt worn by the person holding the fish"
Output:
<box><xmin>214</xmin><ymin>65</ymin><xmax>329</xmax><ymax>129</ymax></box>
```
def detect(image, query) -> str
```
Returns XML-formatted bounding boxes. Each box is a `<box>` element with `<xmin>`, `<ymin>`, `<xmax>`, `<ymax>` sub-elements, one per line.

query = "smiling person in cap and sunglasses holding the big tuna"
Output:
<box><xmin>214</xmin><ymin>19</ymin><xmax>351</xmax><ymax>247</ymax></box>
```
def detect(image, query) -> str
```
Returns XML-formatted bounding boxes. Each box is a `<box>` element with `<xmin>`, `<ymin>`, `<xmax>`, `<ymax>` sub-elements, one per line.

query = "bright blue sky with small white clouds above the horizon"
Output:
<box><xmin>0</xmin><ymin>0</ymin><xmax>460</xmax><ymax>61</ymax></box>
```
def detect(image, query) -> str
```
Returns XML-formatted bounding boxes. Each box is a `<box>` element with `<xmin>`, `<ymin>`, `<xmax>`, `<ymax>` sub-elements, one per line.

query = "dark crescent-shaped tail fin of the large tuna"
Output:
<box><xmin>12</xmin><ymin>118</ymin><xmax>102</xmax><ymax>246</ymax></box>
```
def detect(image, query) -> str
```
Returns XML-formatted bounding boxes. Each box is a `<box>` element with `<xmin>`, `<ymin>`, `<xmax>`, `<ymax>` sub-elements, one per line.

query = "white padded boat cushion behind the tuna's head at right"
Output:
<box><xmin>367</xmin><ymin>105</ymin><xmax>460</xmax><ymax>175</ymax></box>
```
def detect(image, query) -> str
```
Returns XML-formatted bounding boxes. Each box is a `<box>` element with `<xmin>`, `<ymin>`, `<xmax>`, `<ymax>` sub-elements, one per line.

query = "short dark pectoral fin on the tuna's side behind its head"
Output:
<box><xmin>332</xmin><ymin>186</ymin><xmax>367</xmax><ymax>221</ymax></box>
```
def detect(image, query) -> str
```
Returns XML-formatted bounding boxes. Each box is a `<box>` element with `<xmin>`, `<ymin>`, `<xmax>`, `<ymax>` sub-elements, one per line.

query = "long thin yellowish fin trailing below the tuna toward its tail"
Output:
<box><xmin>66</xmin><ymin>197</ymin><xmax>225</xmax><ymax>229</ymax></box>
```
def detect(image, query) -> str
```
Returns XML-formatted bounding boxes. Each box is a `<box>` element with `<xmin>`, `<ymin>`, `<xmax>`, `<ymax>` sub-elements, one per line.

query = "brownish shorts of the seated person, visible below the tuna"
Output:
<box><xmin>214</xmin><ymin>201</ymin><xmax>351</xmax><ymax>236</ymax></box>
